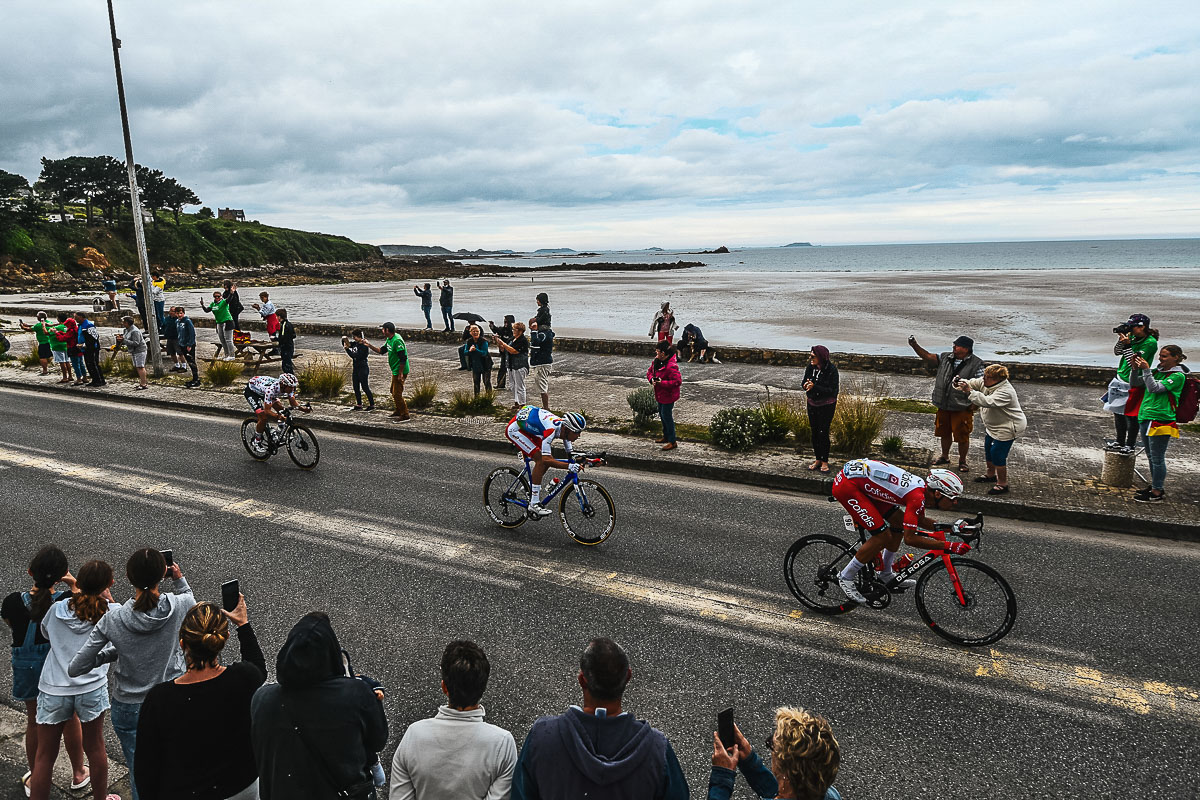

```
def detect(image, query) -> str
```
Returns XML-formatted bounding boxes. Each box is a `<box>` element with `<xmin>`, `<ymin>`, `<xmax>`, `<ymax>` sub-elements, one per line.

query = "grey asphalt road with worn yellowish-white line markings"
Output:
<box><xmin>0</xmin><ymin>389</ymin><xmax>1200</xmax><ymax>798</ymax></box>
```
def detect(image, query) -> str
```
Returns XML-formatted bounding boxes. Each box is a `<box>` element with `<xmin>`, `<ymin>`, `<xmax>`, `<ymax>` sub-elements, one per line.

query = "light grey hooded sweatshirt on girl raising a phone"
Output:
<box><xmin>67</xmin><ymin>578</ymin><xmax>196</xmax><ymax>705</ymax></box>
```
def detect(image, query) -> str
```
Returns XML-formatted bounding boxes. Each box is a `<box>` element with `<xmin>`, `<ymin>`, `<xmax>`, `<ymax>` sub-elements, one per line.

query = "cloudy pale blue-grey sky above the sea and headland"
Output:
<box><xmin>0</xmin><ymin>0</ymin><xmax>1200</xmax><ymax>249</ymax></box>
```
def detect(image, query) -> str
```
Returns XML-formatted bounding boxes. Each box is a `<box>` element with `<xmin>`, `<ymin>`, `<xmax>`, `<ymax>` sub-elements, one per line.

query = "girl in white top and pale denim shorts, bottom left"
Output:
<box><xmin>29</xmin><ymin>561</ymin><xmax>120</xmax><ymax>800</ymax></box>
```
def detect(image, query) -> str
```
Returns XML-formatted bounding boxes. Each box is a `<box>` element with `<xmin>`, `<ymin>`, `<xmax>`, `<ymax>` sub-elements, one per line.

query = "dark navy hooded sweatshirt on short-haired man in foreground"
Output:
<box><xmin>512</xmin><ymin>706</ymin><xmax>689</xmax><ymax>800</ymax></box>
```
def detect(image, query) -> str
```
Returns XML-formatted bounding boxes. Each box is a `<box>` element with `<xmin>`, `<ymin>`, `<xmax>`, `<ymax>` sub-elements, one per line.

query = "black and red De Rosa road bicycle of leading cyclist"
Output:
<box><xmin>784</xmin><ymin>510</ymin><xmax>1016</xmax><ymax>646</ymax></box>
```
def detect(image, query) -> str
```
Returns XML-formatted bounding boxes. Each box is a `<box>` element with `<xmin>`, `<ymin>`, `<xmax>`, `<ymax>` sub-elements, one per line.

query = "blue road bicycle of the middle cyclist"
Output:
<box><xmin>484</xmin><ymin>452</ymin><xmax>617</xmax><ymax>547</ymax></box>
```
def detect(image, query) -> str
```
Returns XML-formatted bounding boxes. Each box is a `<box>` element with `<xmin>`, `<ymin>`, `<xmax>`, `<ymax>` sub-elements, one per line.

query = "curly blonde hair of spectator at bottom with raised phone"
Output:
<box><xmin>772</xmin><ymin>706</ymin><xmax>841</xmax><ymax>800</ymax></box>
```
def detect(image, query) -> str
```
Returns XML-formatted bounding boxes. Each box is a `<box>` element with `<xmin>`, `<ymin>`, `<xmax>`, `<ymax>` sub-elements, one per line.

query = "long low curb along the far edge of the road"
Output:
<box><xmin>0</xmin><ymin>378</ymin><xmax>1200</xmax><ymax>542</ymax></box>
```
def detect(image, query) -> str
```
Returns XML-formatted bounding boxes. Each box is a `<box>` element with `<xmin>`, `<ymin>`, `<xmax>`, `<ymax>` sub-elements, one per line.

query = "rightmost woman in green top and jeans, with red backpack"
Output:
<box><xmin>1133</xmin><ymin>344</ymin><xmax>1188</xmax><ymax>503</ymax></box>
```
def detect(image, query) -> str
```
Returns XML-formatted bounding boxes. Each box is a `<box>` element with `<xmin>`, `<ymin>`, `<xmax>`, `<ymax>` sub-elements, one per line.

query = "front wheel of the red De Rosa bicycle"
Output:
<box><xmin>914</xmin><ymin>558</ymin><xmax>1016</xmax><ymax>648</ymax></box>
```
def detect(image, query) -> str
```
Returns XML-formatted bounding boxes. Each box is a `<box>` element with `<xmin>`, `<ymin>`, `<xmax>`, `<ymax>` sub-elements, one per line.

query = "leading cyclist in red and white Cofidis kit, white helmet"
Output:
<box><xmin>833</xmin><ymin>458</ymin><xmax>971</xmax><ymax>603</ymax></box>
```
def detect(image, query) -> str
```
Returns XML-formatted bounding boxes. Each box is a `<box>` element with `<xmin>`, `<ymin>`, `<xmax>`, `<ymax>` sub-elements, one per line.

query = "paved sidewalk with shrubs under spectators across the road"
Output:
<box><xmin>0</xmin><ymin>330</ymin><xmax>1200</xmax><ymax>535</ymax></box>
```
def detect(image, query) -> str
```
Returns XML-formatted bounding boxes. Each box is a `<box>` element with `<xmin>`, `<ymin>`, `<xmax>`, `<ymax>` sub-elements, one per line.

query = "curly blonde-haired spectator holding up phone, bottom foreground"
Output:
<box><xmin>708</xmin><ymin>708</ymin><xmax>841</xmax><ymax>800</ymax></box>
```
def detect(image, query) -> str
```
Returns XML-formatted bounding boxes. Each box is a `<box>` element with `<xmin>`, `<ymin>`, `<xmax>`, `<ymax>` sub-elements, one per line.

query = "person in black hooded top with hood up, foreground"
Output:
<box><xmin>250</xmin><ymin>612</ymin><xmax>388</xmax><ymax>800</ymax></box>
